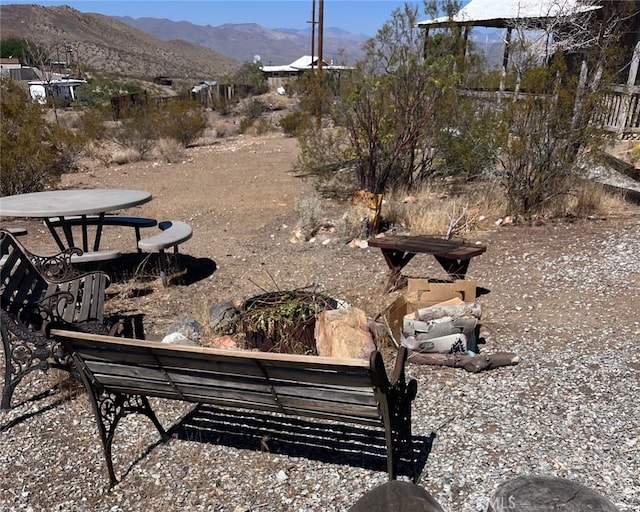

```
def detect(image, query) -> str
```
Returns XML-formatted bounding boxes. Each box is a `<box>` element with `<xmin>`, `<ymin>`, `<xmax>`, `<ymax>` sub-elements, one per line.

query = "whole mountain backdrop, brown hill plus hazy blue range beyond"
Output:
<box><xmin>0</xmin><ymin>4</ymin><xmax>366</xmax><ymax>81</ymax></box>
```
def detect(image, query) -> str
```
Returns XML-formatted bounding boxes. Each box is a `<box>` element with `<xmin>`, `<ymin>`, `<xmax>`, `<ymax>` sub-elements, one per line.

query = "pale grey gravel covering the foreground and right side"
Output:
<box><xmin>0</xmin><ymin>219</ymin><xmax>640</xmax><ymax>512</ymax></box>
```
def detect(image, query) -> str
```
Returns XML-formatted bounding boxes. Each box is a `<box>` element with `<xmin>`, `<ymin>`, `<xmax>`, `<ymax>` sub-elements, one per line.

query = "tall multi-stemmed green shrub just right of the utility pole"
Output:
<box><xmin>301</xmin><ymin>5</ymin><xmax>476</xmax><ymax>194</ymax></box>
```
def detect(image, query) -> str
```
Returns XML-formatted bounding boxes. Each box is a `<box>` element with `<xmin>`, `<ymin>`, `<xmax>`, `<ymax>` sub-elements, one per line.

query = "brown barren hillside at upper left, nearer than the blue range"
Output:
<box><xmin>0</xmin><ymin>5</ymin><xmax>240</xmax><ymax>80</ymax></box>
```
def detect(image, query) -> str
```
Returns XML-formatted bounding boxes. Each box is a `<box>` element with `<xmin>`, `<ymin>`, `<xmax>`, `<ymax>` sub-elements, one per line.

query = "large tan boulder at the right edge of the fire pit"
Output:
<box><xmin>315</xmin><ymin>307</ymin><xmax>376</xmax><ymax>359</ymax></box>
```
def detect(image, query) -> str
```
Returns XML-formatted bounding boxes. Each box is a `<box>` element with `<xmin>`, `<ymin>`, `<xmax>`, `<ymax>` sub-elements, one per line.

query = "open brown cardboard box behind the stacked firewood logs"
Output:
<box><xmin>383</xmin><ymin>279</ymin><xmax>478</xmax><ymax>345</ymax></box>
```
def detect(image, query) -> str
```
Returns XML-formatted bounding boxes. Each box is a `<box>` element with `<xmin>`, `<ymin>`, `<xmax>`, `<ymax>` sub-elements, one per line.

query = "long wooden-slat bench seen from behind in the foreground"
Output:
<box><xmin>49</xmin><ymin>327</ymin><xmax>417</xmax><ymax>486</ymax></box>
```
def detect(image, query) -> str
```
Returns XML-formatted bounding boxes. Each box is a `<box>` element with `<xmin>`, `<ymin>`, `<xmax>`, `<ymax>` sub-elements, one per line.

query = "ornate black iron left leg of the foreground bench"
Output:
<box><xmin>74</xmin><ymin>358</ymin><xmax>169</xmax><ymax>488</ymax></box>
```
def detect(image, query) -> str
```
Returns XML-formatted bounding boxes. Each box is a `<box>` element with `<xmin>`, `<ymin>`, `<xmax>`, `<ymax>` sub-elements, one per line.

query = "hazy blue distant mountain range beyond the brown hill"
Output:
<box><xmin>116</xmin><ymin>16</ymin><xmax>368</xmax><ymax>65</ymax></box>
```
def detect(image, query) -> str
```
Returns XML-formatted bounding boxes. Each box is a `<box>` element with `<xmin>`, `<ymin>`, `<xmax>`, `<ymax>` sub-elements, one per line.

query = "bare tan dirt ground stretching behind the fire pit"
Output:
<box><xmin>2</xmin><ymin>133</ymin><xmax>638</xmax><ymax>339</ymax></box>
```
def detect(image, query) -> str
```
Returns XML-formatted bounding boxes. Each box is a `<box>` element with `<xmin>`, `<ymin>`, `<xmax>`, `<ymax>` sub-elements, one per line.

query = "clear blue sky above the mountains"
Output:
<box><xmin>0</xmin><ymin>0</ymin><xmax>423</xmax><ymax>37</ymax></box>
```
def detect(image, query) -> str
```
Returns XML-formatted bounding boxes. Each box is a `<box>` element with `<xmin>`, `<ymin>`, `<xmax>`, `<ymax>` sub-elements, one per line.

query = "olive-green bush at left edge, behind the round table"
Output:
<box><xmin>0</xmin><ymin>80</ymin><xmax>85</xmax><ymax>196</ymax></box>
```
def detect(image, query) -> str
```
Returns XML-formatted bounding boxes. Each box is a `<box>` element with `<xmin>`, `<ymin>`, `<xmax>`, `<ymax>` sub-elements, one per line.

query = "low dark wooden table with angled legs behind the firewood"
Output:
<box><xmin>368</xmin><ymin>235</ymin><xmax>487</xmax><ymax>289</ymax></box>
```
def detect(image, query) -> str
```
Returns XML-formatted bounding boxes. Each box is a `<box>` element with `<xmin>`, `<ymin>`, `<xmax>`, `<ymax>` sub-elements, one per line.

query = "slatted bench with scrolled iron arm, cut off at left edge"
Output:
<box><xmin>0</xmin><ymin>230</ymin><xmax>109</xmax><ymax>409</ymax></box>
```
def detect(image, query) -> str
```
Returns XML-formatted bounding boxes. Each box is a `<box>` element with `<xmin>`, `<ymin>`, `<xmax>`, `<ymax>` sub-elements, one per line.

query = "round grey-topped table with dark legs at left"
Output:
<box><xmin>0</xmin><ymin>189</ymin><xmax>151</xmax><ymax>251</ymax></box>
